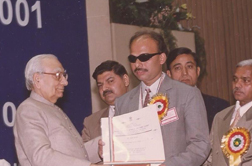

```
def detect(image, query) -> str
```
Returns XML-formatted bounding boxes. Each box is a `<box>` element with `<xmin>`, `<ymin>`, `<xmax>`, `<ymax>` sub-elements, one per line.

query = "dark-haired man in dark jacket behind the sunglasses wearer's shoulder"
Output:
<box><xmin>166</xmin><ymin>47</ymin><xmax>229</xmax><ymax>129</ymax></box>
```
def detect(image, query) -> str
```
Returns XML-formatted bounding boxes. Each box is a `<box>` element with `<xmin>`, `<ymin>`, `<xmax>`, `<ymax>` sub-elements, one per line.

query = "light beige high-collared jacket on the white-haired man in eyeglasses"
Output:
<box><xmin>13</xmin><ymin>92</ymin><xmax>98</xmax><ymax>166</ymax></box>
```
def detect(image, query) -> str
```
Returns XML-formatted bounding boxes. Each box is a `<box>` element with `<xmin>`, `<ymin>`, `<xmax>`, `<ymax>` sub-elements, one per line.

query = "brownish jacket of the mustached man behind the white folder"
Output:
<box><xmin>82</xmin><ymin>107</ymin><xmax>109</xmax><ymax>142</ymax></box>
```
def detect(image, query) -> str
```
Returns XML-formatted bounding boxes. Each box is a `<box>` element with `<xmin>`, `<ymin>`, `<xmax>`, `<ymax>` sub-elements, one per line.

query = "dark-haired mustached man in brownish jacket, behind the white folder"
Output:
<box><xmin>82</xmin><ymin>60</ymin><xmax>129</xmax><ymax>142</ymax></box>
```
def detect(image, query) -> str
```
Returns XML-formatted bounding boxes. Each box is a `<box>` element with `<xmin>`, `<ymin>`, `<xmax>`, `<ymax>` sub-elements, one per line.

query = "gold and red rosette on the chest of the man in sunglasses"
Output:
<box><xmin>149</xmin><ymin>93</ymin><xmax>169</xmax><ymax>121</ymax></box>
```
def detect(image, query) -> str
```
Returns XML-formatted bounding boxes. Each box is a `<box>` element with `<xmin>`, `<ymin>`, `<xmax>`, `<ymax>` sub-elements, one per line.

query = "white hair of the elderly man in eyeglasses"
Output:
<box><xmin>24</xmin><ymin>54</ymin><xmax>58</xmax><ymax>90</ymax></box>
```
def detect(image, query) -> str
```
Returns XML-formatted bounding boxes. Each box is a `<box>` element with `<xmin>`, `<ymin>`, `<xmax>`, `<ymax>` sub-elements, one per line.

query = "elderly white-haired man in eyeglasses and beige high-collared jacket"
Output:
<box><xmin>13</xmin><ymin>54</ymin><xmax>99</xmax><ymax>166</ymax></box>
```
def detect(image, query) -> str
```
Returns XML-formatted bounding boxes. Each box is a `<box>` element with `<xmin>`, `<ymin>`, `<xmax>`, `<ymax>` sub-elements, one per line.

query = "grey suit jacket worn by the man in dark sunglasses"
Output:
<box><xmin>115</xmin><ymin>75</ymin><xmax>210</xmax><ymax>166</ymax></box>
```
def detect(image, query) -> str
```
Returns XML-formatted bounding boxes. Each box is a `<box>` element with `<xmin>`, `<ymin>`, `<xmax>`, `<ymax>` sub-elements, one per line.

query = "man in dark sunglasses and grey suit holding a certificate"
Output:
<box><xmin>115</xmin><ymin>31</ymin><xmax>210</xmax><ymax>166</ymax></box>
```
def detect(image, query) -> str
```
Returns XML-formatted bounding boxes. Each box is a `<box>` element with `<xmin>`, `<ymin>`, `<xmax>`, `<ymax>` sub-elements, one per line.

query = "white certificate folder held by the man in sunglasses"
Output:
<box><xmin>101</xmin><ymin>104</ymin><xmax>165</xmax><ymax>164</ymax></box>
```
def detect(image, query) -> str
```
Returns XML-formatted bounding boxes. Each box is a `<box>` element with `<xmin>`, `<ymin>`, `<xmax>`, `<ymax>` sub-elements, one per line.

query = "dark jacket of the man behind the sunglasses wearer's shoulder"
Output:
<box><xmin>202</xmin><ymin>93</ymin><xmax>229</xmax><ymax>131</ymax></box>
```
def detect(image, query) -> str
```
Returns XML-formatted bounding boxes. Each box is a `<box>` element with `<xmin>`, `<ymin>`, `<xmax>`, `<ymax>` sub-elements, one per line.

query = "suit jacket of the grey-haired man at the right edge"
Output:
<box><xmin>205</xmin><ymin>105</ymin><xmax>252</xmax><ymax>166</ymax></box>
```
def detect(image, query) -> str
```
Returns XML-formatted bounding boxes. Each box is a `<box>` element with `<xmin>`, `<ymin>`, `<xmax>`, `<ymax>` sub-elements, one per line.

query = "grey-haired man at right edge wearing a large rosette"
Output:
<box><xmin>204</xmin><ymin>59</ymin><xmax>252</xmax><ymax>166</ymax></box>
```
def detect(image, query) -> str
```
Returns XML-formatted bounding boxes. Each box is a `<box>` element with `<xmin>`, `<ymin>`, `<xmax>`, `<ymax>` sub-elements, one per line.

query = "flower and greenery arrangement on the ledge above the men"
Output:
<box><xmin>109</xmin><ymin>0</ymin><xmax>206</xmax><ymax>79</ymax></box>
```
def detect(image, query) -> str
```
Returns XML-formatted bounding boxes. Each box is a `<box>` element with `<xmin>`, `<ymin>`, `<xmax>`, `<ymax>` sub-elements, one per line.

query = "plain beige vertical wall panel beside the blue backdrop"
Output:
<box><xmin>86</xmin><ymin>0</ymin><xmax>112</xmax><ymax>112</ymax></box>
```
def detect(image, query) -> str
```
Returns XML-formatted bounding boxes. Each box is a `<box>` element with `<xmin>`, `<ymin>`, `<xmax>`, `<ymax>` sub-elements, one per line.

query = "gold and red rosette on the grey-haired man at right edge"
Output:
<box><xmin>221</xmin><ymin>127</ymin><xmax>250</xmax><ymax>166</ymax></box>
